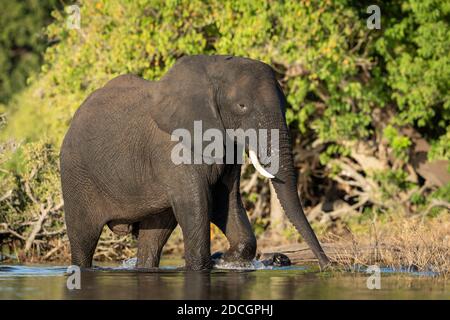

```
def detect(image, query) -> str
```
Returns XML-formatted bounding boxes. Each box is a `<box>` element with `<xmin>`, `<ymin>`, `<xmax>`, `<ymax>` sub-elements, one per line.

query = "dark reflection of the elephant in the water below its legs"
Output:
<box><xmin>63</xmin><ymin>270</ymin><xmax>256</xmax><ymax>300</ymax></box>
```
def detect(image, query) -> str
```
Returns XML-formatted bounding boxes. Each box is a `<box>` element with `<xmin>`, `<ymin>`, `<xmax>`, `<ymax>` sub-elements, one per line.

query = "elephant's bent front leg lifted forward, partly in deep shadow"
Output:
<box><xmin>212</xmin><ymin>165</ymin><xmax>256</xmax><ymax>262</ymax></box>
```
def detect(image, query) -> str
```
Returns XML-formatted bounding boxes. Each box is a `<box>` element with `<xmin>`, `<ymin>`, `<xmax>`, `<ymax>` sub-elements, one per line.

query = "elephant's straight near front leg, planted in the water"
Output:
<box><xmin>171</xmin><ymin>179</ymin><xmax>212</xmax><ymax>270</ymax></box>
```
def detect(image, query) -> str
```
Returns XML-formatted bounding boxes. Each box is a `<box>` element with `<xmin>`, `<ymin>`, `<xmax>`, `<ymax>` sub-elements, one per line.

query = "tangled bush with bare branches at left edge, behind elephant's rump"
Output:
<box><xmin>0</xmin><ymin>142</ymin><xmax>65</xmax><ymax>257</ymax></box>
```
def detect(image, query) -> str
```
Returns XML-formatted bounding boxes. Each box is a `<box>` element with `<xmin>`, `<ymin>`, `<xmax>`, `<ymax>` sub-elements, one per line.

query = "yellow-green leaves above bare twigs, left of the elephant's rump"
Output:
<box><xmin>0</xmin><ymin>142</ymin><xmax>63</xmax><ymax>232</ymax></box>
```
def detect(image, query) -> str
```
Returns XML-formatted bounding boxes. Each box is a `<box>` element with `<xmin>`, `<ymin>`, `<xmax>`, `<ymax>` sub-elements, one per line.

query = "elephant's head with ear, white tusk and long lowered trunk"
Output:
<box><xmin>155</xmin><ymin>56</ymin><xmax>329</xmax><ymax>267</ymax></box>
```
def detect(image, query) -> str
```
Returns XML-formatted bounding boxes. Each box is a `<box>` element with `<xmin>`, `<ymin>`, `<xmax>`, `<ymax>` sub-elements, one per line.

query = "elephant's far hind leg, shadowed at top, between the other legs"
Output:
<box><xmin>136</xmin><ymin>209</ymin><xmax>177</xmax><ymax>268</ymax></box>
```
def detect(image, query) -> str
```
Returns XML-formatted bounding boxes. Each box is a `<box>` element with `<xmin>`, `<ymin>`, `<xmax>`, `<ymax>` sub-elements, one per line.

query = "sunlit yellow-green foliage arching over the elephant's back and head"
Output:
<box><xmin>0</xmin><ymin>0</ymin><xmax>379</xmax><ymax>144</ymax></box>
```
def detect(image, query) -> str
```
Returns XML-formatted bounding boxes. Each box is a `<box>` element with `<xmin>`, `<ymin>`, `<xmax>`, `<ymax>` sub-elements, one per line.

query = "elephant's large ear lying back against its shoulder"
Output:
<box><xmin>151</xmin><ymin>56</ymin><xmax>225</xmax><ymax>154</ymax></box>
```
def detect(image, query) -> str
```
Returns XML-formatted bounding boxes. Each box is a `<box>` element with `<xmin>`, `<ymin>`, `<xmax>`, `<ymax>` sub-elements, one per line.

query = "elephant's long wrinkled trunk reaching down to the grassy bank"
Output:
<box><xmin>253</xmin><ymin>127</ymin><xmax>330</xmax><ymax>268</ymax></box>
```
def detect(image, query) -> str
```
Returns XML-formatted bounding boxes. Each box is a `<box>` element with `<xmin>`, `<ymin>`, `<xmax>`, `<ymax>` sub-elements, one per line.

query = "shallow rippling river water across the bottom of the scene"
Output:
<box><xmin>0</xmin><ymin>260</ymin><xmax>450</xmax><ymax>299</ymax></box>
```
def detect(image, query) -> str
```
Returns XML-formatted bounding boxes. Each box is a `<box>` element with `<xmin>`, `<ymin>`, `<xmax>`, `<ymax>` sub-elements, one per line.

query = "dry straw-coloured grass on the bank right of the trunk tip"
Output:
<box><xmin>326</xmin><ymin>213</ymin><xmax>450</xmax><ymax>277</ymax></box>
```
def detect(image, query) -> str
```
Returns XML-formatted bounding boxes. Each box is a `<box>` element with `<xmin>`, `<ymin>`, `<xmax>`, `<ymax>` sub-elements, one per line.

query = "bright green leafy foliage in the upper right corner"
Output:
<box><xmin>377</xmin><ymin>0</ymin><xmax>450</xmax><ymax>129</ymax></box>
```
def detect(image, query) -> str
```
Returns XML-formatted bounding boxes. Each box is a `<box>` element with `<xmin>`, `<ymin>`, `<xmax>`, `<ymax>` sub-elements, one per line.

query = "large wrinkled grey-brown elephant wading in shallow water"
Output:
<box><xmin>61</xmin><ymin>56</ymin><xmax>329</xmax><ymax>270</ymax></box>
